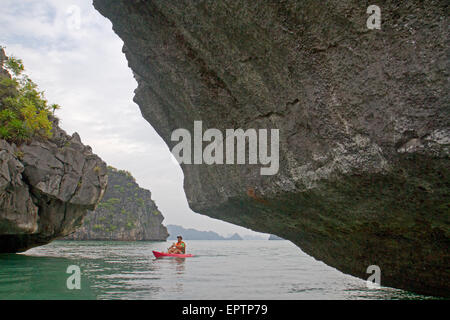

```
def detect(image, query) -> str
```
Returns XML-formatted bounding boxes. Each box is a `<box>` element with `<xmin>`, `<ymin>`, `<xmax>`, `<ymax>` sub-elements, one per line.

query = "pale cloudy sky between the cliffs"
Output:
<box><xmin>0</xmin><ymin>0</ymin><xmax>266</xmax><ymax>239</ymax></box>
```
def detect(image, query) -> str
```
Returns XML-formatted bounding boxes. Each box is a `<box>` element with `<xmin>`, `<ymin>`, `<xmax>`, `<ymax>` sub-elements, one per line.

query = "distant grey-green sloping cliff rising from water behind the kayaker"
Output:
<box><xmin>65</xmin><ymin>167</ymin><xmax>169</xmax><ymax>241</ymax></box>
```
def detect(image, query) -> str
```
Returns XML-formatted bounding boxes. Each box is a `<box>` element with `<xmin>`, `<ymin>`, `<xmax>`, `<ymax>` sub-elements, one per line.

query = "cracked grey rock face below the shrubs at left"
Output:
<box><xmin>0</xmin><ymin>50</ymin><xmax>107</xmax><ymax>253</ymax></box>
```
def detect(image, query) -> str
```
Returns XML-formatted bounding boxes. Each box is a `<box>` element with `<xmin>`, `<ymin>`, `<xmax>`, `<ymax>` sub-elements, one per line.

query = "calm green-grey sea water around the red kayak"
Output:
<box><xmin>0</xmin><ymin>241</ymin><xmax>436</xmax><ymax>299</ymax></box>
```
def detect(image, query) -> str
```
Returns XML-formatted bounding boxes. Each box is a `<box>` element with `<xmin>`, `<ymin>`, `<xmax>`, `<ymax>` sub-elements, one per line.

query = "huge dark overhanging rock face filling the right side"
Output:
<box><xmin>94</xmin><ymin>0</ymin><xmax>450</xmax><ymax>296</ymax></box>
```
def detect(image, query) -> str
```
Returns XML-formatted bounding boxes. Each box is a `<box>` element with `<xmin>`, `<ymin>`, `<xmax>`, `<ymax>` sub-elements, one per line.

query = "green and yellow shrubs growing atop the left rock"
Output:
<box><xmin>0</xmin><ymin>53</ymin><xmax>60</xmax><ymax>143</ymax></box>
